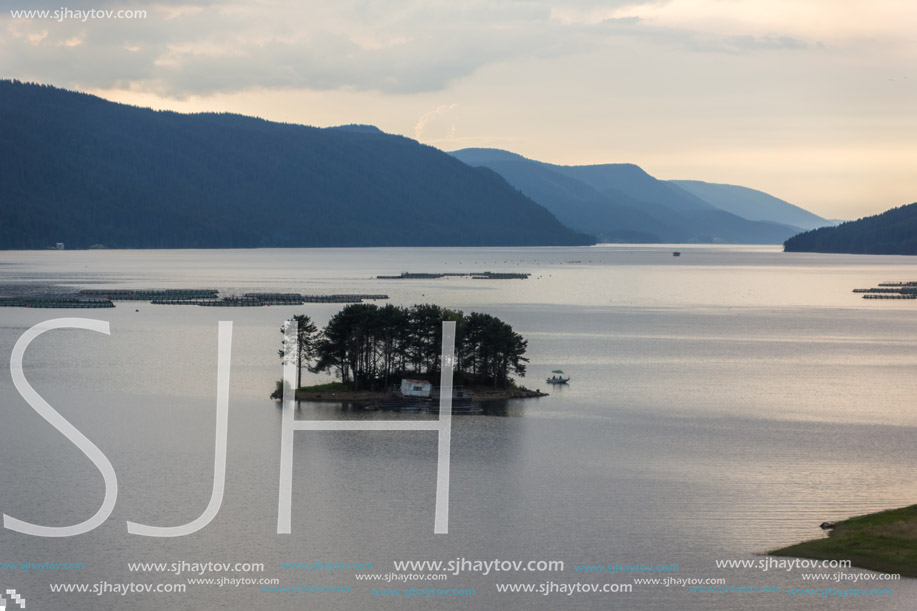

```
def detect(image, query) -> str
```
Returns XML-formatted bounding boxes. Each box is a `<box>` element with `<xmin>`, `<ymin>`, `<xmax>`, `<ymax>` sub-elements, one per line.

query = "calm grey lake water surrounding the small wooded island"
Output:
<box><xmin>0</xmin><ymin>245</ymin><xmax>917</xmax><ymax>611</ymax></box>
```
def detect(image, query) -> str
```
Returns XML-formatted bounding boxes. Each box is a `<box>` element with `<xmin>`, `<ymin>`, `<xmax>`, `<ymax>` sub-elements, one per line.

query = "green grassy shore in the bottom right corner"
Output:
<box><xmin>768</xmin><ymin>505</ymin><xmax>917</xmax><ymax>577</ymax></box>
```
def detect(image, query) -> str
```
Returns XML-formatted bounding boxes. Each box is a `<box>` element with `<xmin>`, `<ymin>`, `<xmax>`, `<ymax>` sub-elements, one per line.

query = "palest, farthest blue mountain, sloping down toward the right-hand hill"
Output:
<box><xmin>669</xmin><ymin>180</ymin><xmax>836</xmax><ymax>229</ymax></box>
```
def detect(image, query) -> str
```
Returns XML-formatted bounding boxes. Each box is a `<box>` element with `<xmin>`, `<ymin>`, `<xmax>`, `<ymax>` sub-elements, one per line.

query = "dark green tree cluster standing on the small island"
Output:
<box><xmin>280</xmin><ymin>304</ymin><xmax>528</xmax><ymax>391</ymax></box>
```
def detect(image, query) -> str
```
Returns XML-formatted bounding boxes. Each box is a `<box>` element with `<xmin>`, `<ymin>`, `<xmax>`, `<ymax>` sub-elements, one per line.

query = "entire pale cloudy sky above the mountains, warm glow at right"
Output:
<box><xmin>0</xmin><ymin>0</ymin><xmax>917</xmax><ymax>218</ymax></box>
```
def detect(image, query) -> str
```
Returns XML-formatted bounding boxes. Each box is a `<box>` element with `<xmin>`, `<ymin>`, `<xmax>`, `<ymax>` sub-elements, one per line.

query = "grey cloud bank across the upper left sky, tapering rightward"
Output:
<box><xmin>0</xmin><ymin>0</ymin><xmax>816</xmax><ymax>98</ymax></box>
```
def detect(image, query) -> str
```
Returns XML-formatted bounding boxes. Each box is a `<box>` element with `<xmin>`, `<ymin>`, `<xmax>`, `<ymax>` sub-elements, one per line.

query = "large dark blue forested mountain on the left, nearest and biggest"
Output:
<box><xmin>0</xmin><ymin>81</ymin><xmax>593</xmax><ymax>249</ymax></box>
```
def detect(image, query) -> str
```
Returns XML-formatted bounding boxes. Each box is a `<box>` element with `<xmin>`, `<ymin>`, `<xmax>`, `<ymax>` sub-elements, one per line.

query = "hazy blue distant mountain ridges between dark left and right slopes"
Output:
<box><xmin>452</xmin><ymin>148</ymin><xmax>830</xmax><ymax>244</ymax></box>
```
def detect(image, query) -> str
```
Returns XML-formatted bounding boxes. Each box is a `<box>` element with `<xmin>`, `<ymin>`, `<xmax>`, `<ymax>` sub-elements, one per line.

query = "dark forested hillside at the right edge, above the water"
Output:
<box><xmin>783</xmin><ymin>203</ymin><xmax>917</xmax><ymax>255</ymax></box>
